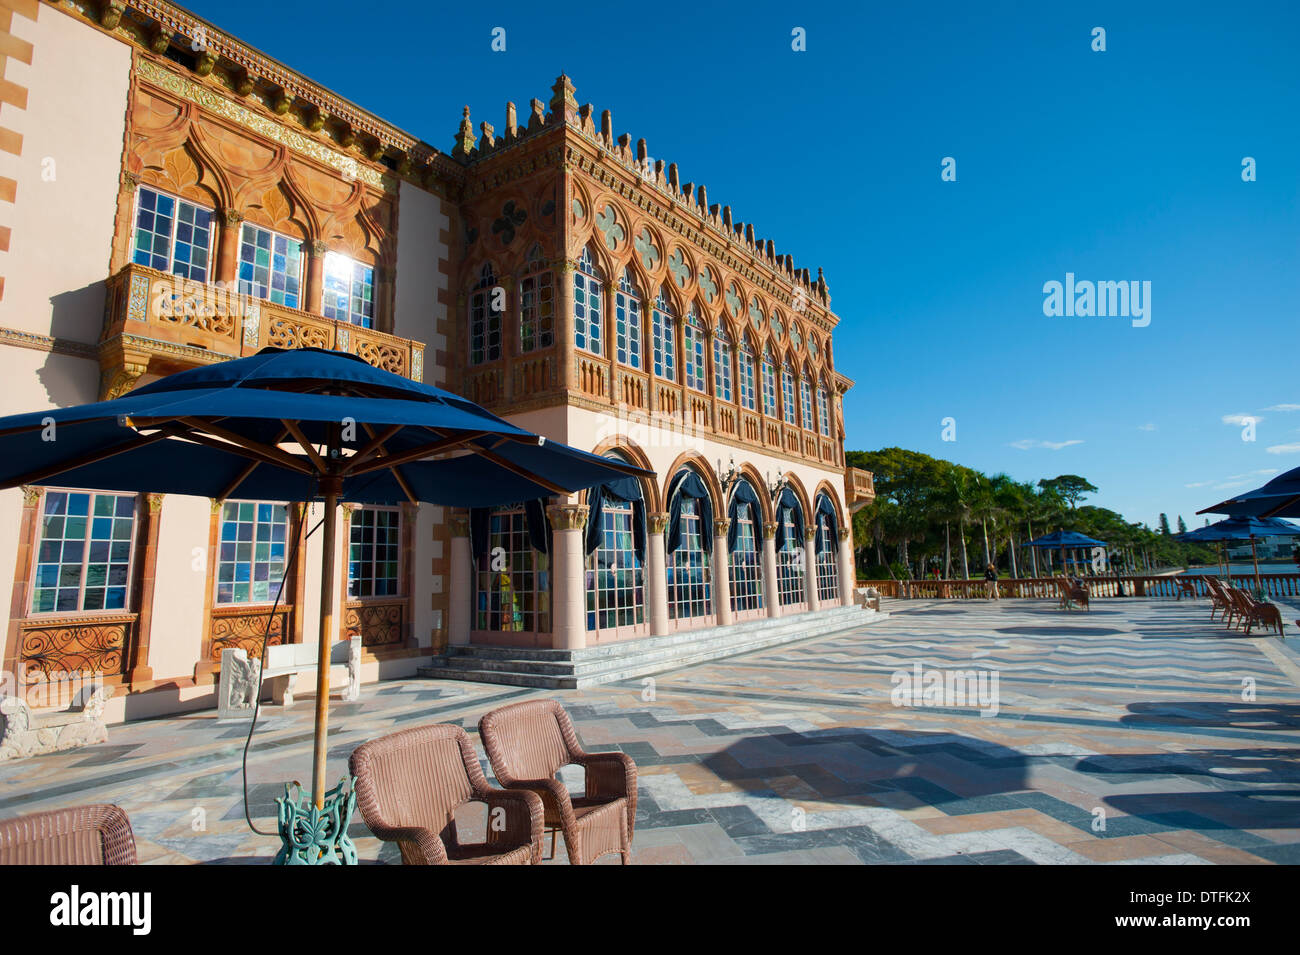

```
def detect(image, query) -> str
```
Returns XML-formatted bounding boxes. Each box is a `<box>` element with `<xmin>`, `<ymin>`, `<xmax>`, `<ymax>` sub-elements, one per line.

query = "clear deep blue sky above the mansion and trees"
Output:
<box><xmin>189</xmin><ymin>0</ymin><xmax>1300</xmax><ymax>524</ymax></box>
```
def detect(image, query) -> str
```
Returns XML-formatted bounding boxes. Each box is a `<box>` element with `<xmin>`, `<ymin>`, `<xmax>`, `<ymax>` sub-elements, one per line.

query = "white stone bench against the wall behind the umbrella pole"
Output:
<box><xmin>217</xmin><ymin>637</ymin><xmax>361</xmax><ymax>720</ymax></box>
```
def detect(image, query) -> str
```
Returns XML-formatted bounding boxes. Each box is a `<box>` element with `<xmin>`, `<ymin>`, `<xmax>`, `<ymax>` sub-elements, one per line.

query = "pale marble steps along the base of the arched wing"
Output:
<box><xmin>419</xmin><ymin>607</ymin><xmax>889</xmax><ymax>690</ymax></box>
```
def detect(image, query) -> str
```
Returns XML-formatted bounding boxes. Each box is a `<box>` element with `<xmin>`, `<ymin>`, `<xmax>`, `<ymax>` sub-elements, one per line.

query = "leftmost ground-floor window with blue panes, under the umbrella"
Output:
<box><xmin>31</xmin><ymin>491</ymin><xmax>135</xmax><ymax>613</ymax></box>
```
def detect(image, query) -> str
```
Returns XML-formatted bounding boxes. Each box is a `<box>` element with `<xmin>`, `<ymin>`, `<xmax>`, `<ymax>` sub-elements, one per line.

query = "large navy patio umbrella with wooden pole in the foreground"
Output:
<box><xmin>0</xmin><ymin>348</ymin><xmax>649</xmax><ymax>826</ymax></box>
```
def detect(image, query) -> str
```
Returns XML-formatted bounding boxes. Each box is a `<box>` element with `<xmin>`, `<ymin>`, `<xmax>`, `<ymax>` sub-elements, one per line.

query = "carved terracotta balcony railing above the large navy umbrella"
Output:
<box><xmin>99</xmin><ymin>265</ymin><xmax>424</xmax><ymax>398</ymax></box>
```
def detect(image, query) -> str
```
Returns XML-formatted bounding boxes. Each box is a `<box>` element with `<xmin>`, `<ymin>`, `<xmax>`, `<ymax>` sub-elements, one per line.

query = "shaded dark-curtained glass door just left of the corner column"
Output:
<box><xmin>475</xmin><ymin>504</ymin><xmax>551</xmax><ymax>634</ymax></box>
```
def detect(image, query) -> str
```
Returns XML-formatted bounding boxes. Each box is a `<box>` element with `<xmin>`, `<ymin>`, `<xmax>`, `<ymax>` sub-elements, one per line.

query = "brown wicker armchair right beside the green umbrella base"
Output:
<box><xmin>348</xmin><ymin>724</ymin><xmax>542</xmax><ymax>865</ymax></box>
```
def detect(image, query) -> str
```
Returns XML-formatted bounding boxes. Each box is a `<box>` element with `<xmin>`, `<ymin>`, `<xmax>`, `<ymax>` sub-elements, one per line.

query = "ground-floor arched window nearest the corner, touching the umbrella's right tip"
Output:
<box><xmin>586</xmin><ymin>452</ymin><xmax>646</xmax><ymax>639</ymax></box>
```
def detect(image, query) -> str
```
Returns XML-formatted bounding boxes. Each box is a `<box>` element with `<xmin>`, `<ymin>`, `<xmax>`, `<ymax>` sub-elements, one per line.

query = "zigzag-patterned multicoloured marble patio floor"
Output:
<box><xmin>0</xmin><ymin>599</ymin><xmax>1300</xmax><ymax>864</ymax></box>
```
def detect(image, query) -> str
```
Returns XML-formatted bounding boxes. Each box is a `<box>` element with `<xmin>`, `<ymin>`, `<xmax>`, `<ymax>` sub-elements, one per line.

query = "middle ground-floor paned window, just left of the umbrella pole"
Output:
<box><xmin>217</xmin><ymin>500</ymin><xmax>289</xmax><ymax>604</ymax></box>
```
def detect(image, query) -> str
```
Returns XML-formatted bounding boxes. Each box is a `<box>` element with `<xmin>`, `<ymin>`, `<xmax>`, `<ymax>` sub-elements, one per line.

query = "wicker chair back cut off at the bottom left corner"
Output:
<box><xmin>0</xmin><ymin>806</ymin><xmax>135</xmax><ymax>865</ymax></box>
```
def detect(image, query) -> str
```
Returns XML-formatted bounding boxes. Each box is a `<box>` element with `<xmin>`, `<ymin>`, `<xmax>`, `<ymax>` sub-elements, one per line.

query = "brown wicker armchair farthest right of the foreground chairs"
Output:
<box><xmin>478</xmin><ymin>700</ymin><xmax>637</xmax><ymax>865</ymax></box>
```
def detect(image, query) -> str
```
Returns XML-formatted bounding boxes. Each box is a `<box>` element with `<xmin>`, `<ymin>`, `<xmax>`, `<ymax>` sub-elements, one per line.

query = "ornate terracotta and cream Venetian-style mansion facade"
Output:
<box><xmin>0</xmin><ymin>0</ymin><xmax>872</xmax><ymax>719</ymax></box>
